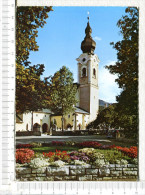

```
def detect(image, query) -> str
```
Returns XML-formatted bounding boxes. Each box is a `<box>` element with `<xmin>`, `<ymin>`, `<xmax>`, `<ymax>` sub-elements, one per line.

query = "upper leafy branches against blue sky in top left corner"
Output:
<box><xmin>16</xmin><ymin>7</ymin><xmax>52</xmax><ymax>66</ymax></box>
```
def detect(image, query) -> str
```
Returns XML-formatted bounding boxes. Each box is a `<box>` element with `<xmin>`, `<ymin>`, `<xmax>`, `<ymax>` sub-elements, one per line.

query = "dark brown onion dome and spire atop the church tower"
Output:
<box><xmin>81</xmin><ymin>17</ymin><xmax>96</xmax><ymax>54</ymax></box>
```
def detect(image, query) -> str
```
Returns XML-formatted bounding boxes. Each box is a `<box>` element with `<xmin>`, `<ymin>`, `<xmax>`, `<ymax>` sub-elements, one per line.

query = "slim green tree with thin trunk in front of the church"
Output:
<box><xmin>50</xmin><ymin>66</ymin><xmax>77</xmax><ymax>131</ymax></box>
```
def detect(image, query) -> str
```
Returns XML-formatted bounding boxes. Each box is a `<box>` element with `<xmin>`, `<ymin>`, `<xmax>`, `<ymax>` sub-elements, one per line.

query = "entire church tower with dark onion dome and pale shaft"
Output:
<box><xmin>77</xmin><ymin>17</ymin><xmax>99</xmax><ymax>122</ymax></box>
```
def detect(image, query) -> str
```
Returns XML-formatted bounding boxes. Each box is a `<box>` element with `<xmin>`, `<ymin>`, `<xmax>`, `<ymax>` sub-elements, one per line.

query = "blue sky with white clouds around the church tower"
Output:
<box><xmin>29</xmin><ymin>6</ymin><xmax>125</xmax><ymax>103</ymax></box>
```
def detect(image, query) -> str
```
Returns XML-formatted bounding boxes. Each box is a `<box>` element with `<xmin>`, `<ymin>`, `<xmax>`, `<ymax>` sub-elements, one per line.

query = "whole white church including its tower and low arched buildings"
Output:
<box><xmin>16</xmin><ymin>17</ymin><xmax>99</xmax><ymax>134</ymax></box>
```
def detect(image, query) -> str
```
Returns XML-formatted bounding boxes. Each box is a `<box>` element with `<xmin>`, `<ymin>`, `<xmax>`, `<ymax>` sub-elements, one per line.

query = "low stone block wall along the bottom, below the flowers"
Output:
<box><xmin>16</xmin><ymin>164</ymin><xmax>138</xmax><ymax>181</ymax></box>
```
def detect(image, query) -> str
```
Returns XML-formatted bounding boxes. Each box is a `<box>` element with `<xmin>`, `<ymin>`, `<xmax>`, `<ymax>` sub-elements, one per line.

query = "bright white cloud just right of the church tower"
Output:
<box><xmin>99</xmin><ymin>61</ymin><xmax>121</xmax><ymax>103</ymax></box>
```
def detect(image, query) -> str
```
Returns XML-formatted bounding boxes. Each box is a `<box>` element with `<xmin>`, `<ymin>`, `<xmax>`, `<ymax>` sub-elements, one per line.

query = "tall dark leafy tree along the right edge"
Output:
<box><xmin>106</xmin><ymin>7</ymin><xmax>139</xmax><ymax>137</ymax></box>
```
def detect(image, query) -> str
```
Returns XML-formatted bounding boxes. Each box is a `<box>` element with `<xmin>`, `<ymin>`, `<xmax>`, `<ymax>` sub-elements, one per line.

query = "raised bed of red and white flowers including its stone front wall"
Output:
<box><xmin>16</xmin><ymin>145</ymin><xmax>137</xmax><ymax>181</ymax></box>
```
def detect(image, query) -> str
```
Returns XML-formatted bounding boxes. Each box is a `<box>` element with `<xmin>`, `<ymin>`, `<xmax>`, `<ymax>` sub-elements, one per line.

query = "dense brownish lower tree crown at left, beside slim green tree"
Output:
<box><xmin>16</xmin><ymin>64</ymin><xmax>50</xmax><ymax>113</ymax></box>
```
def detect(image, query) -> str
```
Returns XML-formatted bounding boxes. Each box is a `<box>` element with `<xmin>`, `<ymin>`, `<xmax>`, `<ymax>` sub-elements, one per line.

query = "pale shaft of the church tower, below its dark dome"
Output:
<box><xmin>77</xmin><ymin>53</ymin><xmax>100</xmax><ymax>122</ymax></box>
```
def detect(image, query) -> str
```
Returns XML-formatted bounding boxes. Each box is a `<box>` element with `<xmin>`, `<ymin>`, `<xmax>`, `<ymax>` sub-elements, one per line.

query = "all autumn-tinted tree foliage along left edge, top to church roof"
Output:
<box><xmin>16</xmin><ymin>7</ymin><xmax>52</xmax><ymax>113</ymax></box>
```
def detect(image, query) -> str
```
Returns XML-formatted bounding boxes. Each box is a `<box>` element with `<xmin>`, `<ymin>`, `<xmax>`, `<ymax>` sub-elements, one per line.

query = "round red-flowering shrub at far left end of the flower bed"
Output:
<box><xmin>16</xmin><ymin>148</ymin><xmax>34</xmax><ymax>164</ymax></box>
